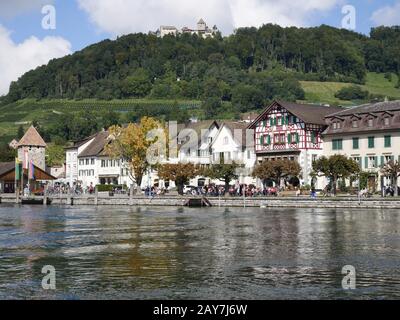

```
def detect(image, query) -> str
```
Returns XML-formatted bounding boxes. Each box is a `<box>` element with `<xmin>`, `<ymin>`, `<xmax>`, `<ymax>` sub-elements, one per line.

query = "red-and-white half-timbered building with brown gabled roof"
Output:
<box><xmin>249</xmin><ymin>101</ymin><xmax>343</xmax><ymax>188</ymax></box>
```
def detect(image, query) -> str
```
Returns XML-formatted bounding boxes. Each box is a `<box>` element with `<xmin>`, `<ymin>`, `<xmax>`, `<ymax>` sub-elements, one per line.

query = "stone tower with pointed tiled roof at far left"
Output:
<box><xmin>17</xmin><ymin>126</ymin><xmax>47</xmax><ymax>171</ymax></box>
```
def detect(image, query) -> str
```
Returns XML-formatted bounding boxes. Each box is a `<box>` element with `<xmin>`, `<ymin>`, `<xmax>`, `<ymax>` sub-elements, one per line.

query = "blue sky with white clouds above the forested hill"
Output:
<box><xmin>0</xmin><ymin>0</ymin><xmax>400</xmax><ymax>96</ymax></box>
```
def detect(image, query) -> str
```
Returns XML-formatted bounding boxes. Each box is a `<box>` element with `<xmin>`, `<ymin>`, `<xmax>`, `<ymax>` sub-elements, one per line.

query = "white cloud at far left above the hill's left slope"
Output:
<box><xmin>0</xmin><ymin>25</ymin><xmax>71</xmax><ymax>96</ymax></box>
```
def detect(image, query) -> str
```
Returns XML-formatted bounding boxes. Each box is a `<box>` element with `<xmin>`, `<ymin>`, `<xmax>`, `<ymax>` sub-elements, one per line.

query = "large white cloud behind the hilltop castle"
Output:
<box><xmin>77</xmin><ymin>0</ymin><xmax>343</xmax><ymax>35</ymax></box>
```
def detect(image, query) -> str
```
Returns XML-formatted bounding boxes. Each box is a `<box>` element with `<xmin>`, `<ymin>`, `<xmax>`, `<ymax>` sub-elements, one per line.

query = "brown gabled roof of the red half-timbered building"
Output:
<box><xmin>249</xmin><ymin>101</ymin><xmax>344</xmax><ymax>128</ymax></box>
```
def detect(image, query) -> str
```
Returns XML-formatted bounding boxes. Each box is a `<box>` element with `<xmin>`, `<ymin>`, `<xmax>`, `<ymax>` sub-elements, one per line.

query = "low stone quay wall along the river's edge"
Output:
<box><xmin>0</xmin><ymin>194</ymin><xmax>400</xmax><ymax>209</ymax></box>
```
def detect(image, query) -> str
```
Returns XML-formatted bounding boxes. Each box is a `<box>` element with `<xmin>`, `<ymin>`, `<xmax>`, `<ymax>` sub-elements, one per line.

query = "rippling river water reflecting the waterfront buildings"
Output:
<box><xmin>0</xmin><ymin>205</ymin><xmax>400</xmax><ymax>300</ymax></box>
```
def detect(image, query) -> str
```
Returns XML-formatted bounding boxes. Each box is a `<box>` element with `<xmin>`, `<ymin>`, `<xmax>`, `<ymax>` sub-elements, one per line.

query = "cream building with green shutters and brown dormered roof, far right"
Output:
<box><xmin>323</xmin><ymin>101</ymin><xmax>400</xmax><ymax>191</ymax></box>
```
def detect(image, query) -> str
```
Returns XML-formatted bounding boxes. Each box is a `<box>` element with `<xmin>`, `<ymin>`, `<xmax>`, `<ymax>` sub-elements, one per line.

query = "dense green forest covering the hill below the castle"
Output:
<box><xmin>3</xmin><ymin>25</ymin><xmax>400</xmax><ymax>112</ymax></box>
